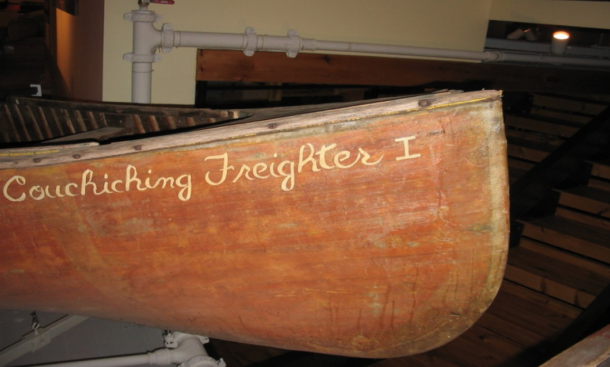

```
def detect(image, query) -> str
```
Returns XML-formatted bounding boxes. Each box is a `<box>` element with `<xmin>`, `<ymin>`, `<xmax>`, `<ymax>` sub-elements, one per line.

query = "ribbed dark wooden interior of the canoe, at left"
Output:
<box><xmin>0</xmin><ymin>97</ymin><xmax>246</xmax><ymax>144</ymax></box>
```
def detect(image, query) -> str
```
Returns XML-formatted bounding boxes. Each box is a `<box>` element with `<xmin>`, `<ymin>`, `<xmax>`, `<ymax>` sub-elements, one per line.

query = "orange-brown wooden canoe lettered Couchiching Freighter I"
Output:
<box><xmin>0</xmin><ymin>91</ymin><xmax>508</xmax><ymax>357</ymax></box>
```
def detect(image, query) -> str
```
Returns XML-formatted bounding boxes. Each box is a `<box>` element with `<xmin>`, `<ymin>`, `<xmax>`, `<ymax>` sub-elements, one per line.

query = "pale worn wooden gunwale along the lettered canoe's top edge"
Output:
<box><xmin>0</xmin><ymin>90</ymin><xmax>501</xmax><ymax>169</ymax></box>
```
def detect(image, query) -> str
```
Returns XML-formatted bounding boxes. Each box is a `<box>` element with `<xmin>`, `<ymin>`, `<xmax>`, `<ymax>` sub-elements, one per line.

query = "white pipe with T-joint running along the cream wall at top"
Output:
<box><xmin>124</xmin><ymin>6</ymin><xmax>610</xmax><ymax>103</ymax></box>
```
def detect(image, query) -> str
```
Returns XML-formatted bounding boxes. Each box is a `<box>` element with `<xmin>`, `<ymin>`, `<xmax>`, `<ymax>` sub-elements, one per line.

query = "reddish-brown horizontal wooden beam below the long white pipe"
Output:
<box><xmin>197</xmin><ymin>50</ymin><xmax>610</xmax><ymax>93</ymax></box>
